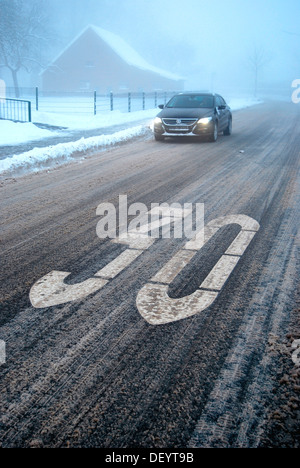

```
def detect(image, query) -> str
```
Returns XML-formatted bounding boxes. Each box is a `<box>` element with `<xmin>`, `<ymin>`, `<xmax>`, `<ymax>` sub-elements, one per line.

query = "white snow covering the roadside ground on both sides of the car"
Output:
<box><xmin>0</xmin><ymin>98</ymin><xmax>262</xmax><ymax>175</ymax></box>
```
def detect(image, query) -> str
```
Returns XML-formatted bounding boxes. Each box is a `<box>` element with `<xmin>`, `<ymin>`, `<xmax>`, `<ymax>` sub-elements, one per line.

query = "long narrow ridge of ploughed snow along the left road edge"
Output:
<box><xmin>0</xmin><ymin>125</ymin><xmax>146</xmax><ymax>174</ymax></box>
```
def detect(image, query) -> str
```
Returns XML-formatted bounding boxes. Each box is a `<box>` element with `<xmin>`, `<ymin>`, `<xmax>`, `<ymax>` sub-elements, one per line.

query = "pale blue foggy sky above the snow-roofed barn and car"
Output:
<box><xmin>45</xmin><ymin>0</ymin><xmax>300</xmax><ymax>95</ymax></box>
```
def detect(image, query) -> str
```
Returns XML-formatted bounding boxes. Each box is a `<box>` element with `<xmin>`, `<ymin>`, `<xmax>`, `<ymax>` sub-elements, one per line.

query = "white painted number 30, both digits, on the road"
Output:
<box><xmin>30</xmin><ymin>214</ymin><xmax>260</xmax><ymax>325</ymax></box>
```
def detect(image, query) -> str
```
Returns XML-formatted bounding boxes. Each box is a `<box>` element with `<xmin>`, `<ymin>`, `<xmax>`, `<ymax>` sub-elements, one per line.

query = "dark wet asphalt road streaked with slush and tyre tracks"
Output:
<box><xmin>0</xmin><ymin>102</ymin><xmax>300</xmax><ymax>448</ymax></box>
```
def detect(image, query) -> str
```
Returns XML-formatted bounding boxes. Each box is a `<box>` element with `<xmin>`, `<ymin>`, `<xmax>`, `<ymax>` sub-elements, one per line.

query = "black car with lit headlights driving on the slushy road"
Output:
<box><xmin>153</xmin><ymin>93</ymin><xmax>232</xmax><ymax>142</ymax></box>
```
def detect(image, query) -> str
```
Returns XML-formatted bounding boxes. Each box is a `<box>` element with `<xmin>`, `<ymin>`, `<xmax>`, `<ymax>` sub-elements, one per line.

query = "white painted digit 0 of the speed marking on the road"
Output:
<box><xmin>136</xmin><ymin>215</ymin><xmax>259</xmax><ymax>325</ymax></box>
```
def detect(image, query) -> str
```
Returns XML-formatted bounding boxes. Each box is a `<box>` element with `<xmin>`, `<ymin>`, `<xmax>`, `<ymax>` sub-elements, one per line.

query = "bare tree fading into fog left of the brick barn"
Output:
<box><xmin>0</xmin><ymin>0</ymin><xmax>51</xmax><ymax>97</ymax></box>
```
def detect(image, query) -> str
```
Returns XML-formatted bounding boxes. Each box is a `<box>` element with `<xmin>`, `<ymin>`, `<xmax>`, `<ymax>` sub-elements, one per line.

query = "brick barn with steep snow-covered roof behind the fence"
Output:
<box><xmin>41</xmin><ymin>25</ymin><xmax>184</xmax><ymax>93</ymax></box>
